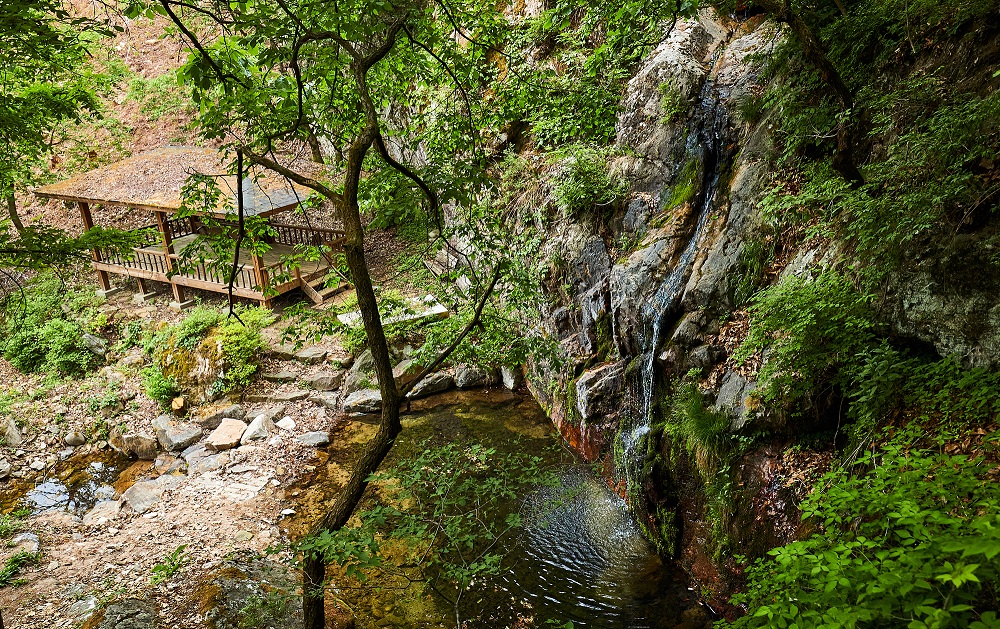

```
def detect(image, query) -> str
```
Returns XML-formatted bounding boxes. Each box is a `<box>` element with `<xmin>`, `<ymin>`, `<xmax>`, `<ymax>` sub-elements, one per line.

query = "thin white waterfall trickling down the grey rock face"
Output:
<box><xmin>616</xmin><ymin>62</ymin><xmax>728</xmax><ymax>508</ymax></box>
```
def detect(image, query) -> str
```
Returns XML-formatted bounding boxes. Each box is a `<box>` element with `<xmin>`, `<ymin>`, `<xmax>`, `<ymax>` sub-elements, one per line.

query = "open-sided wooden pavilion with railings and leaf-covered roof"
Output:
<box><xmin>35</xmin><ymin>146</ymin><xmax>346</xmax><ymax>309</ymax></box>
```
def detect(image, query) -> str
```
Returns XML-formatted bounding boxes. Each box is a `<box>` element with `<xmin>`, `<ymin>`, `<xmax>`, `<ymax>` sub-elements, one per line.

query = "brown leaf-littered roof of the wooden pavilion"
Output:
<box><xmin>35</xmin><ymin>146</ymin><xmax>311</xmax><ymax>216</ymax></box>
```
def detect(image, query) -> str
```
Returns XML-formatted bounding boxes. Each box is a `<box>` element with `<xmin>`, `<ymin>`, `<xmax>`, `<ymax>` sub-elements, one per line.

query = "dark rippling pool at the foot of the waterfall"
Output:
<box><xmin>316</xmin><ymin>393</ymin><xmax>711</xmax><ymax>629</ymax></box>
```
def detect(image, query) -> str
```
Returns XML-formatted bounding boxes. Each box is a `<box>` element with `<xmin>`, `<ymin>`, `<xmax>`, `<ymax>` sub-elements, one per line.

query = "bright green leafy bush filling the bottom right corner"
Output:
<box><xmin>727</xmin><ymin>430</ymin><xmax>1000</xmax><ymax>629</ymax></box>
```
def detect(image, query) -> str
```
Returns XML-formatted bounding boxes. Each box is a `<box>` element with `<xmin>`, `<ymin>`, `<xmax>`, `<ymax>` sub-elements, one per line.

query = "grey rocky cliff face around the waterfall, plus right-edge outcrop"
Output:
<box><xmin>529</xmin><ymin>13</ymin><xmax>1000</xmax><ymax>600</ymax></box>
